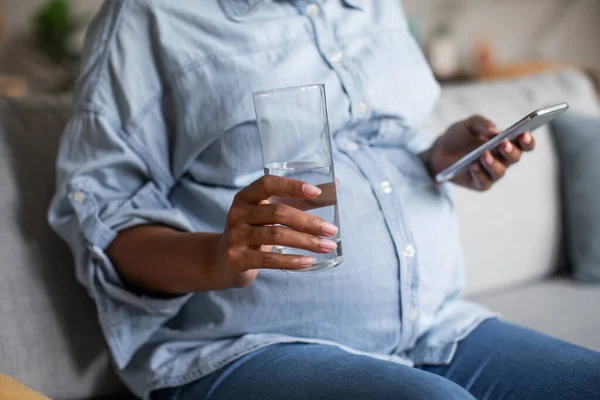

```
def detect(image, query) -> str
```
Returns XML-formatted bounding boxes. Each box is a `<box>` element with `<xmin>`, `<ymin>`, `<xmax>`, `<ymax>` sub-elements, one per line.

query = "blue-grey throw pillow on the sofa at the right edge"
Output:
<box><xmin>552</xmin><ymin>113</ymin><xmax>600</xmax><ymax>283</ymax></box>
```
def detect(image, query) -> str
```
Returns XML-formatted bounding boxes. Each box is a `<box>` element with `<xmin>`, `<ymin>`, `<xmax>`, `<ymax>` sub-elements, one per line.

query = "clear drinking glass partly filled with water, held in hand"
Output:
<box><xmin>254</xmin><ymin>85</ymin><xmax>342</xmax><ymax>272</ymax></box>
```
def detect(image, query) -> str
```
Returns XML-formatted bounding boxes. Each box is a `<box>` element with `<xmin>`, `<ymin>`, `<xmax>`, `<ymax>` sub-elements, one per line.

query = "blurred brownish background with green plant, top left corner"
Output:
<box><xmin>0</xmin><ymin>0</ymin><xmax>102</xmax><ymax>97</ymax></box>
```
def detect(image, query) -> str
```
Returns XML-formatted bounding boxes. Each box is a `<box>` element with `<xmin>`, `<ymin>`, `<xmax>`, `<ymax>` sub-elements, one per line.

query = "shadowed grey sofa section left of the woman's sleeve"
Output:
<box><xmin>0</xmin><ymin>98</ymin><xmax>123</xmax><ymax>399</ymax></box>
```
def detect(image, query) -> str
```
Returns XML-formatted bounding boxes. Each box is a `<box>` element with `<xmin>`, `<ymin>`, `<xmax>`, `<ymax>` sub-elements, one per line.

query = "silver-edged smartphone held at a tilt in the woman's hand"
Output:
<box><xmin>435</xmin><ymin>103</ymin><xmax>569</xmax><ymax>183</ymax></box>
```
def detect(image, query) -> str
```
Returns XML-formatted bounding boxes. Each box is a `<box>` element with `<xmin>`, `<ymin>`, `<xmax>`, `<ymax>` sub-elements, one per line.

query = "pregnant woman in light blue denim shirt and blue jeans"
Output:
<box><xmin>49</xmin><ymin>0</ymin><xmax>600</xmax><ymax>400</ymax></box>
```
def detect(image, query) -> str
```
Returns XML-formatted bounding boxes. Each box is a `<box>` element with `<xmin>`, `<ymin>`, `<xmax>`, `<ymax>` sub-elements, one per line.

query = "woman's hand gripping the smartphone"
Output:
<box><xmin>425</xmin><ymin>115</ymin><xmax>535</xmax><ymax>191</ymax></box>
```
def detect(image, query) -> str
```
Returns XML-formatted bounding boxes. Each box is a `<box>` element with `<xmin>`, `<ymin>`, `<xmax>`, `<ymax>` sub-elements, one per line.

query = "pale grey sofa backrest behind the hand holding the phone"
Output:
<box><xmin>430</xmin><ymin>70</ymin><xmax>598</xmax><ymax>294</ymax></box>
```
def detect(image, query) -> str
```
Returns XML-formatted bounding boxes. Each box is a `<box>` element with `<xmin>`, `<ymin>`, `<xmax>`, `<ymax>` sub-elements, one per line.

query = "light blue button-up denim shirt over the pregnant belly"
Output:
<box><xmin>49</xmin><ymin>0</ymin><xmax>491</xmax><ymax>398</ymax></box>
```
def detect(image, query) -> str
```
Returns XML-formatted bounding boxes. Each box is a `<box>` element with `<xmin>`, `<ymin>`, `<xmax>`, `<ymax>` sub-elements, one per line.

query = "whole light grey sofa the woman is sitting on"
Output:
<box><xmin>0</xmin><ymin>70</ymin><xmax>600</xmax><ymax>399</ymax></box>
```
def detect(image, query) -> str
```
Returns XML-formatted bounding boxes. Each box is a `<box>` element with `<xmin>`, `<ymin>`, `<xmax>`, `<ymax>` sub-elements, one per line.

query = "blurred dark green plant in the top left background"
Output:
<box><xmin>34</xmin><ymin>0</ymin><xmax>77</xmax><ymax>62</ymax></box>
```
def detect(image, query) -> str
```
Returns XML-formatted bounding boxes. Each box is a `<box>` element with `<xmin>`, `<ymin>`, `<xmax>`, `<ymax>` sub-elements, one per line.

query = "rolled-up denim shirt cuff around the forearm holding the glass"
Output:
<box><xmin>69</xmin><ymin>181</ymin><xmax>192</xmax><ymax>369</ymax></box>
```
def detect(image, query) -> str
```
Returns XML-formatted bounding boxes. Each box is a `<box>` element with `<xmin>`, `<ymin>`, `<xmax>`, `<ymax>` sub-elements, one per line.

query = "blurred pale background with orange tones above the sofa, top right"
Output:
<box><xmin>404</xmin><ymin>0</ymin><xmax>600</xmax><ymax>80</ymax></box>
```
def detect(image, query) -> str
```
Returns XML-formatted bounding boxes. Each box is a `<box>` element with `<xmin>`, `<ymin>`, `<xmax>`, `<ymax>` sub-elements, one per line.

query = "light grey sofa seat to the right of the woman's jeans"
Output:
<box><xmin>472</xmin><ymin>277</ymin><xmax>600</xmax><ymax>351</ymax></box>
